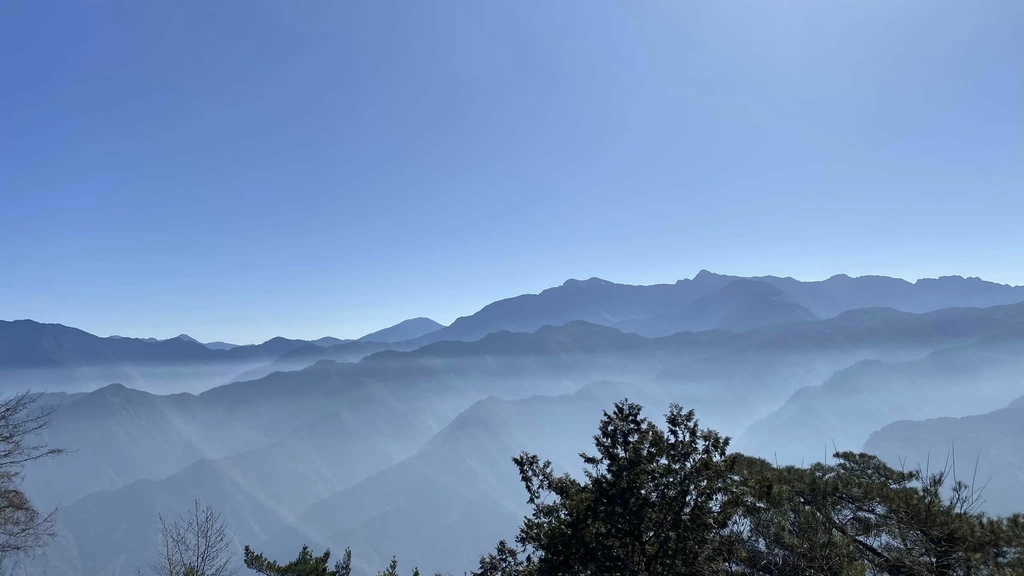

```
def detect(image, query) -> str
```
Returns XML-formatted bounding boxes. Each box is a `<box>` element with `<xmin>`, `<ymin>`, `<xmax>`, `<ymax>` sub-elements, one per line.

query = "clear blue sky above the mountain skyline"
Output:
<box><xmin>0</xmin><ymin>0</ymin><xmax>1024</xmax><ymax>342</ymax></box>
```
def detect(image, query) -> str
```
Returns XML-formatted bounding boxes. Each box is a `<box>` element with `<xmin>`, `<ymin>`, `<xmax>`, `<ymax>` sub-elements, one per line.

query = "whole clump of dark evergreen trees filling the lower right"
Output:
<box><xmin>476</xmin><ymin>401</ymin><xmax>1024</xmax><ymax>576</ymax></box>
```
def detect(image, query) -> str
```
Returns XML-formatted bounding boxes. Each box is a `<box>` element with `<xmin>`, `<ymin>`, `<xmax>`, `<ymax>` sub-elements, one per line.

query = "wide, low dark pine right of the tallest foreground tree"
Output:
<box><xmin>734</xmin><ymin>452</ymin><xmax>1024</xmax><ymax>576</ymax></box>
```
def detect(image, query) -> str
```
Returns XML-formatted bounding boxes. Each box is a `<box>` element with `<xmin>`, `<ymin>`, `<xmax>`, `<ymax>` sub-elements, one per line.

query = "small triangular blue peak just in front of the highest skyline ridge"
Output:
<box><xmin>615</xmin><ymin>280</ymin><xmax>817</xmax><ymax>336</ymax></box>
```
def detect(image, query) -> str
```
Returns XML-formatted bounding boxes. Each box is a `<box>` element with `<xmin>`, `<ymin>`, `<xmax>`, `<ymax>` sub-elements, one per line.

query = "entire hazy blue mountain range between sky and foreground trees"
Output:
<box><xmin>6</xmin><ymin>272</ymin><xmax>1024</xmax><ymax>576</ymax></box>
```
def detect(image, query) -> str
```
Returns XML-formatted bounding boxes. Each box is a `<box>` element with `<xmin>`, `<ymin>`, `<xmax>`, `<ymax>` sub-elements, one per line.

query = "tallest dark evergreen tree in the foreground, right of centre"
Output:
<box><xmin>478</xmin><ymin>402</ymin><xmax>732</xmax><ymax>576</ymax></box>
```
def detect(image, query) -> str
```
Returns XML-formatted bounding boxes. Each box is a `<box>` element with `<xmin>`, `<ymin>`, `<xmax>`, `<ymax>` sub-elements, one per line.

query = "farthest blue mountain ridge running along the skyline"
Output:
<box><xmin>8</xmin><ymin>271</ymin><xmax>1024</xmax><ymax>390</ymax></box>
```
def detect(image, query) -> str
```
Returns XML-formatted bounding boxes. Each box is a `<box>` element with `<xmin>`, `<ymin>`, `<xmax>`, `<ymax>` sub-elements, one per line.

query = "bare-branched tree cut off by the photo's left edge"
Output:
<box><xmin>0</xmin><ymin>393</ymin><xmax>63</xmax><ymax>573</ymax></box>
